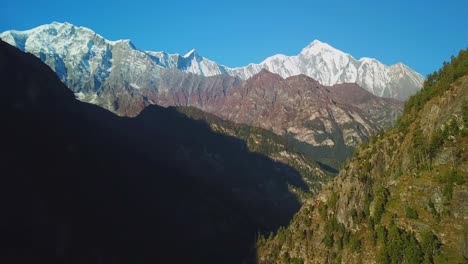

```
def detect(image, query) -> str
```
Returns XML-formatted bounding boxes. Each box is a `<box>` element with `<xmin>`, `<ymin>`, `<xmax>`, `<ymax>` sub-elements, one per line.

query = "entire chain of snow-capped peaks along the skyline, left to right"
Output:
<box><xmin>0</xmin><ymin>22</ymin><xmax>424</xmax><ymax>100</ymax></box>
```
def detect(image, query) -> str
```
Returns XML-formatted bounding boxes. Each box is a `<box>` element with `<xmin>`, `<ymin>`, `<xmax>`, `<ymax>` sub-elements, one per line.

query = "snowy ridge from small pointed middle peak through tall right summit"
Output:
<box><xmin>147</xmin><ymin>40</ymin><xmax>424</xmax><ymax>100</ymax></box>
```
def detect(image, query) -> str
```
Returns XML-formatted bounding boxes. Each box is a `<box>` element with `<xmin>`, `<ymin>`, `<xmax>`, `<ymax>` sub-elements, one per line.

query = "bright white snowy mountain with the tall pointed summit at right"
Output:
<box><xmin>225</xmin><ymin>40</ymin><xmax>424</xmax><ymax>100</ymax></box>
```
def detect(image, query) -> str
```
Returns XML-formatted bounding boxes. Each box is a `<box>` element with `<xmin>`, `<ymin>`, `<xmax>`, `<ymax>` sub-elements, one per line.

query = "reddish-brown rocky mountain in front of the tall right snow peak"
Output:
<box><xmin>197</xmin><ymin>70</ymin><xmax>402</xmax><ymax>165</ymax></box>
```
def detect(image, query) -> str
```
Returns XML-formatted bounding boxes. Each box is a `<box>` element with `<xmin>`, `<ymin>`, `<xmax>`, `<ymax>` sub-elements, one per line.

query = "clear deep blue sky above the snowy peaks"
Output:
<box><xmin>0</xmin><ymin>0</ymin><xmax>468</xmax><ymax>75</ymax></box>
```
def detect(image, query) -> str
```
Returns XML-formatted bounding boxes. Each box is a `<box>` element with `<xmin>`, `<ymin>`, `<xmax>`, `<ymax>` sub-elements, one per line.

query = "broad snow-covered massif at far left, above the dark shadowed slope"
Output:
<box><xmin>0</xmin><ymin>22</ymin><xmax>161</xmax><ymax>94</ymax></box>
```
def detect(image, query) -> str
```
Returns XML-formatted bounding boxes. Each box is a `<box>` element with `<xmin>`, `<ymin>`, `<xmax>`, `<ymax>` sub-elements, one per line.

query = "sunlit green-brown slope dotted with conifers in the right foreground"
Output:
<box><xmin>257</xmin><ymin>50</ymin><xmax>468</xmax><ymax>263</ymax></box>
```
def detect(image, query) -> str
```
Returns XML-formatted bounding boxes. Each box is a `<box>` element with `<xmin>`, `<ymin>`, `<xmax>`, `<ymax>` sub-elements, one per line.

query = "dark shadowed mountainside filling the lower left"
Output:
<box><xmin>0</xmin><ymin>41</ymin><xmax>307</xmax><ymax>263</ymax></box>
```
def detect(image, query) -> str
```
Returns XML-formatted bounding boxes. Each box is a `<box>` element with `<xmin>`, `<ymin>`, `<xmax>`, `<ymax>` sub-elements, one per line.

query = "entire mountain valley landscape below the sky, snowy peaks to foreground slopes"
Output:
<box><xmin>0</xmin><ymin>17</ymin><xmax>468</xmax><ymax>264</ymax></box>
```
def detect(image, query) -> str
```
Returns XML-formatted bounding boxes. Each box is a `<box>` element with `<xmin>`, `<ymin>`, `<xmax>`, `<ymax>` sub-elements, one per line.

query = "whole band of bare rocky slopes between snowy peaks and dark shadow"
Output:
<box><xmin>95</xmin><ymin>70</ymin><xmax>403</xmax><ymax>166</ymax></box>
